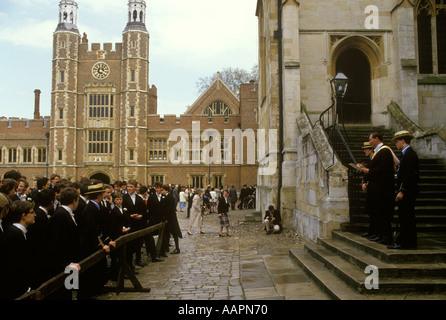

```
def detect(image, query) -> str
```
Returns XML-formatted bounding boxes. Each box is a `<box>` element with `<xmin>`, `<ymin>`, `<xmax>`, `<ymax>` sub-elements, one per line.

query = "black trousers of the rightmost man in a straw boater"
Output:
<box><xmin>396</xmin><ymin>194</ymin><xmax>417</xmax><ymax>247</ymax></box>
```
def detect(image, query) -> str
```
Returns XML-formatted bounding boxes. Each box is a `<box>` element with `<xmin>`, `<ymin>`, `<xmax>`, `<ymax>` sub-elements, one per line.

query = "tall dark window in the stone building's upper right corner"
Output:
<box><xmin>416</xmin><ymin>0</ymin><xmax>446</xmax><ymax>74</ymax></box>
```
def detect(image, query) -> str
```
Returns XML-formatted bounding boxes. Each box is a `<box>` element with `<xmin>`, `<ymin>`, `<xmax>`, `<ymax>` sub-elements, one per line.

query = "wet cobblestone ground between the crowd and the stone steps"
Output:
<box><xmin>97</xmin><ymin>209</ymin><xmax>329</xmax><ymax>300</ymax></box>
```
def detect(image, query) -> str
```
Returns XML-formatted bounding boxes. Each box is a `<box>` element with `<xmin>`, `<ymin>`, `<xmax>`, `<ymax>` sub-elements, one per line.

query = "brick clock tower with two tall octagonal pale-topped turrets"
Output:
<box><xmin>50</xmin><ymin>0</ymin><xmax>157</xmax><ymax>179</ymax></box>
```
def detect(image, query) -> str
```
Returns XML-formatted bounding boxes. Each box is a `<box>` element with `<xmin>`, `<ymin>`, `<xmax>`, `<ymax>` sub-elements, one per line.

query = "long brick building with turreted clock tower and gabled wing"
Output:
<box><xmin>0</xmin><ymin>0</ymin><xmax>257</xmax><ymax>187</ymax></box>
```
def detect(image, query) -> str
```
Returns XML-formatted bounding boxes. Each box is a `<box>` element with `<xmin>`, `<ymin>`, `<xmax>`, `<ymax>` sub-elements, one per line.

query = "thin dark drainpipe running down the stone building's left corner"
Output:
<box><xmin>274</xmin><ymin>0</ymin><xmax>283</xmax><ymax>211</ymax></box>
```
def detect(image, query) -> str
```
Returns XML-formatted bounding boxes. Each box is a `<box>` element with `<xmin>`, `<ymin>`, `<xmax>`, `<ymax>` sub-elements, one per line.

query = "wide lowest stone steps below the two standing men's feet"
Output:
<box><xmin>290</xmin><ymin>231</ymin><xmax>446</xmax><ymax>300</ymax></box>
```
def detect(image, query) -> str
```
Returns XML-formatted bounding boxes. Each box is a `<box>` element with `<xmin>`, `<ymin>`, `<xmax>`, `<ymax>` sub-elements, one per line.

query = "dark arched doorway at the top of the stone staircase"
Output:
<box><xmin>336</xmin><ymin>48</ymin><xmax>372</xmax><ymax>124</ymax></box>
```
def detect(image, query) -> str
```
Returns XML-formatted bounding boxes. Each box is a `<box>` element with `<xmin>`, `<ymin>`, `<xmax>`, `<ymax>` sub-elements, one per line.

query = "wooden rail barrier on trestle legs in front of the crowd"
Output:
<box><xmin>16</xmin><ymin>223</ymin><xmax>164</xmax><ymax>300</ymax></box>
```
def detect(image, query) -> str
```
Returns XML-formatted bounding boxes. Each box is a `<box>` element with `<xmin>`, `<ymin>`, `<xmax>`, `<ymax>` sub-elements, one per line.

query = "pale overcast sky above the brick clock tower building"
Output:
<box><xmin>0</xmin><ymin>0</ymin><xmax>258</xmax><ymax>118</ymax></box>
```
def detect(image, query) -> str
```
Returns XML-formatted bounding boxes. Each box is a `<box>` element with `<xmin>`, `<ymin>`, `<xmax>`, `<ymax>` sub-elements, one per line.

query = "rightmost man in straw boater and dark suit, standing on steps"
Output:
<box><xmin>387</xmin><ymin>131</ymin><xmax>419</xmax><ymax>249</ymax></box>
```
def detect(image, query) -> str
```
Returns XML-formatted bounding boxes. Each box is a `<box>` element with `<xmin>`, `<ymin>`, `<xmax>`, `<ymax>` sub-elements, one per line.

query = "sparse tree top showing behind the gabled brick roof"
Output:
<box><xmin>196</xmin><ymin>65</ymin><xmax>258</xmax><ymax>97</ymax></box>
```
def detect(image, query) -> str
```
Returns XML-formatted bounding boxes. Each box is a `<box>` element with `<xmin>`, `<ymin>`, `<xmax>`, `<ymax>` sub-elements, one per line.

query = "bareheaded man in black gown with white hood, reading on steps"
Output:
<box><xmin>358</xmin><ymin>132</ymin><xmax>399</xmax><ymax>245</ymax></box>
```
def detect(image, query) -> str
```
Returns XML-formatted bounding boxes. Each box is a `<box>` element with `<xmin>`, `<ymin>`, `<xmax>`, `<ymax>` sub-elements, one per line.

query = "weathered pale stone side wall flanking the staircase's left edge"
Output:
<box><xmin>293</xmin><ymin>113</ymin><xmax>349</xmax><ymax>242</ymax></box>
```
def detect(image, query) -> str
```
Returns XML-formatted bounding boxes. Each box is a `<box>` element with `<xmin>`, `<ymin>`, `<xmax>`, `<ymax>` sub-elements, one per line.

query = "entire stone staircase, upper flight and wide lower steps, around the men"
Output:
<box><xmin>290</xmin><ymin>126</ymin><xmax>446</xmax><ymax>300</ymax></box>
